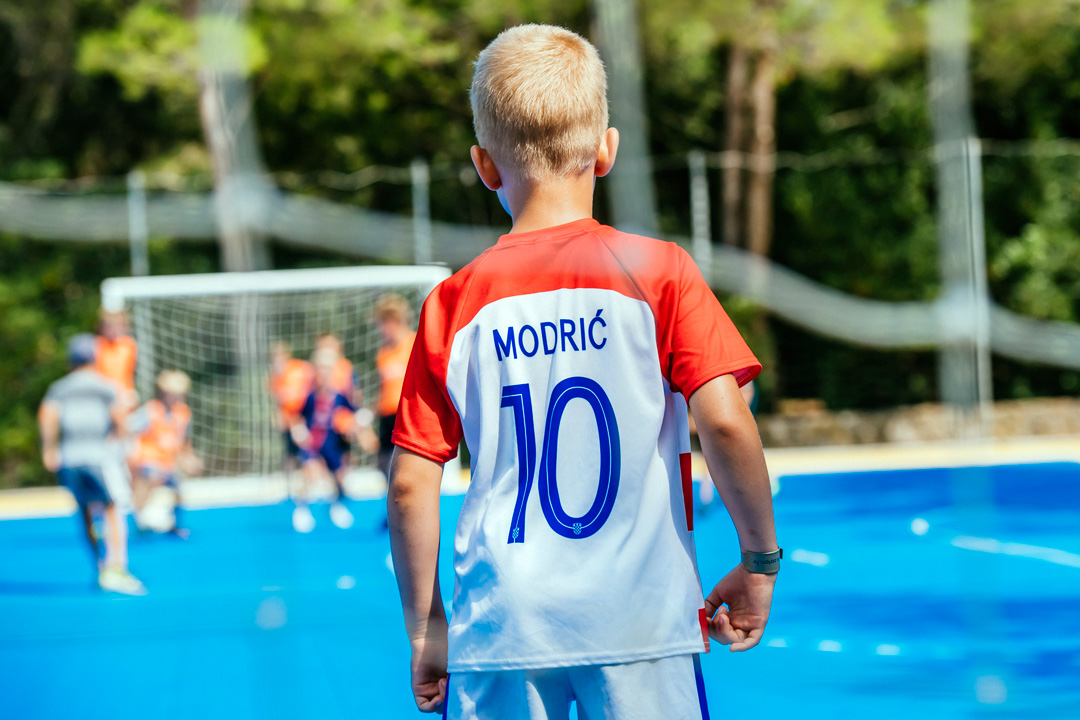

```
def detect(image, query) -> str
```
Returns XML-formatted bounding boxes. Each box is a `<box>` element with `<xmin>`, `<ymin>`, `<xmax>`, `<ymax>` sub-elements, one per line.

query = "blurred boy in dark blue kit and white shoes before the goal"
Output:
<box><xmin>291</xmin><ymin>348</ymin><xmax>355</xmax><ymax>532</ymax></box>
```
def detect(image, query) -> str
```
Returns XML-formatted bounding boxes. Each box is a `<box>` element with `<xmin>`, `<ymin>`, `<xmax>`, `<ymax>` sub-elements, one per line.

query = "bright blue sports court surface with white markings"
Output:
<box><xmin>0</xmin><ymin>463</ymin><xmax>1080</xmax><ymax>720</ymax></box>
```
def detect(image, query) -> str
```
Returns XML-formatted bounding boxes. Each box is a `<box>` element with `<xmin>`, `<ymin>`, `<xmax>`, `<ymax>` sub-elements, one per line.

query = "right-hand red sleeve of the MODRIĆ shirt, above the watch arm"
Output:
<box><xmin>658</xmin><ymin>246</ymin><xmax>761</xmax><ymax>398</ymax></box>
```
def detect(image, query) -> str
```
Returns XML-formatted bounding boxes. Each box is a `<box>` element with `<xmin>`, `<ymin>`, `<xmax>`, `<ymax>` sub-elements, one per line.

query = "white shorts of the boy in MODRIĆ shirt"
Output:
<box><xmin>443</xmin><ymin>655</ymin><xmax>708</xmax><ymax>720</ymax></box>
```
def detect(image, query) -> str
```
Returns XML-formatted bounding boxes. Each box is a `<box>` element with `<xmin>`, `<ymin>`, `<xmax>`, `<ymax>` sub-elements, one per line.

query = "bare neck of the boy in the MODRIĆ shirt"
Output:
<box><xmin>503</xmin><ymin>168</ymin><xmax>596</xmax><ymax>234</ymax></box>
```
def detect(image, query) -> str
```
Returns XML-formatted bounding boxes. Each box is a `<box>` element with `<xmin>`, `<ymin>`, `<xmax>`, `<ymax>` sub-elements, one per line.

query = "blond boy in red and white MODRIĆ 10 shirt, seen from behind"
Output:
<box><xmin>388</xmin><ymin>25</ymin><xmax>780</xmax><ymax>720</ymax></box>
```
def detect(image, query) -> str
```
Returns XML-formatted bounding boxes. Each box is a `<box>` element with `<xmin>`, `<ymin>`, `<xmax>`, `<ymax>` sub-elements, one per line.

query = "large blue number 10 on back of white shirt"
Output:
<box><xmin>501</xmin><ymin>377</ymin><xmax>622</xmax><ymax>543</ymax></box>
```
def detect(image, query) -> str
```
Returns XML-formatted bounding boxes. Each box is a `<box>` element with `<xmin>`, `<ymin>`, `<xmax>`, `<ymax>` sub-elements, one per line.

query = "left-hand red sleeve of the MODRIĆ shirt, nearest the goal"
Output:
<box><xmin>393</xmin><ymin>283</ymin><xmax>462</xmax><ymax>462</ymax></box>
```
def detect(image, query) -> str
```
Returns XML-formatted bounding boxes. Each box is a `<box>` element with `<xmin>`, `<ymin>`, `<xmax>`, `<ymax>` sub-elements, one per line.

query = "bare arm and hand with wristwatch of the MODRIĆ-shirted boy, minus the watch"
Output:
<box><xmin>690</xmin><ymin>375</ymin><xmax>778</xmax><ymax>652</ymax></box>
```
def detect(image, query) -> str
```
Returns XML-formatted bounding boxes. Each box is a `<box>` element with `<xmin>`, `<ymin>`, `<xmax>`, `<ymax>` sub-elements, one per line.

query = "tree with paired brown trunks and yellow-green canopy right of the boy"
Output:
<box><xmin>646</xmin><ymin>0</ymin><xmax>914</xmax><ymax>255</ymax></box>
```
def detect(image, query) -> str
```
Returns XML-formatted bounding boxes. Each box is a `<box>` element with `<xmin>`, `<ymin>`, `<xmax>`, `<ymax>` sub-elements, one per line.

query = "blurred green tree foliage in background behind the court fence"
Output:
<box><xmin>0</xmin><ymin>0</ymin><xmax>1080</xmax><ymax>485</ymax></box>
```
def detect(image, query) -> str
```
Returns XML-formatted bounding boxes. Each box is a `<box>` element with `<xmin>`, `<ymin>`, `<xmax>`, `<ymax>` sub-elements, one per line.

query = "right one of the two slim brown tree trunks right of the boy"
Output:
<box><xmin>746</xmin><ymin>42</ymin><xmax>777</xmax><ymax>256</ymax></box>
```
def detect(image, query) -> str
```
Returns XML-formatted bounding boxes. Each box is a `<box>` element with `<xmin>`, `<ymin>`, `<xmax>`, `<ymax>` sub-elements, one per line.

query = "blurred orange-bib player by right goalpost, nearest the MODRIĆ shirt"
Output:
<box><xmin>375</xmin><ymin>295</ymin><xmax>416</xmax><ymax>481</ymax></box>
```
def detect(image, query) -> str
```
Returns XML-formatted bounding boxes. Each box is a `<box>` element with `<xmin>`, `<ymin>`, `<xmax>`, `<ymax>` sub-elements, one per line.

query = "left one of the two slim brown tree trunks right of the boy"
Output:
<box><xmin>720</xmin><ymin>42</ymin><xmax>750</xmax><ymax>246</ymax></box>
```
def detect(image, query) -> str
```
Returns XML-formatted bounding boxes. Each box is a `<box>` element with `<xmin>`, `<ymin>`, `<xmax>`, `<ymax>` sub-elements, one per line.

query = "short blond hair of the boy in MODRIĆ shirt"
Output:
<box><xmin>469</xmin><ymin>25</ymin><xmax>608</xmax><ymax>180</ymax></box>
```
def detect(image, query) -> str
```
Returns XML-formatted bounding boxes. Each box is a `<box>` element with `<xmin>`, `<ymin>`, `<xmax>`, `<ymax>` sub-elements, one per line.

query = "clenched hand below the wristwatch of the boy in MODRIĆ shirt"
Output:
<box><xmin>705</xmin><ymin>565</ymin><xmax>777</xmax><ymax>652</ymax></box>
